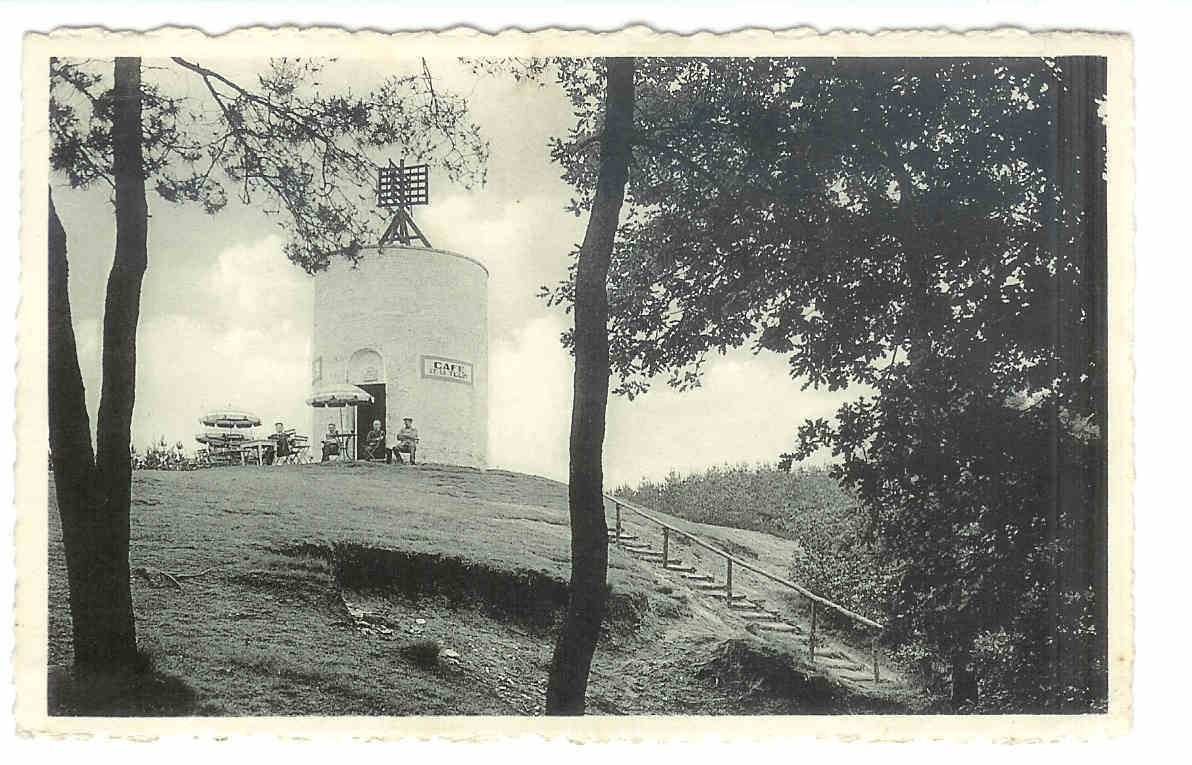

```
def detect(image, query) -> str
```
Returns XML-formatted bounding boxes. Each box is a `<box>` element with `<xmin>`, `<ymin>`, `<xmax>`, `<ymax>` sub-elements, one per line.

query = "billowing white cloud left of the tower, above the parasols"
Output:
<box><xmin>65</xmin><ymin>235</ymin><xmax>313</xmax><ymax>450</ymax></box>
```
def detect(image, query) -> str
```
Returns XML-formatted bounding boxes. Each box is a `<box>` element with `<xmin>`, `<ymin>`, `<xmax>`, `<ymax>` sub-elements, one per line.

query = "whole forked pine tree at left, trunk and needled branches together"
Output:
<box><xmin>49</xmin><ymin>57</ymin><xmax>488</xmax><ymax>672</ymax></box>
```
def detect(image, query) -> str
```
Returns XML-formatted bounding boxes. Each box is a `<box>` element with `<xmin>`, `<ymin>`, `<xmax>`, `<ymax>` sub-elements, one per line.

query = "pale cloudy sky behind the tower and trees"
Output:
<box><xmin>51</xmin><ymin>55</ymin><xmax>867</xmax><ymax>486</ymax></box>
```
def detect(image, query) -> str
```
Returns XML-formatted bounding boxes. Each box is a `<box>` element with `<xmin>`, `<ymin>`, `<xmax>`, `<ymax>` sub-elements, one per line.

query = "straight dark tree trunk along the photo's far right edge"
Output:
<box><xmin>1049</xmin><ymin>56</ymin><xmax>1109</xmax><ymax>711</ymax></box>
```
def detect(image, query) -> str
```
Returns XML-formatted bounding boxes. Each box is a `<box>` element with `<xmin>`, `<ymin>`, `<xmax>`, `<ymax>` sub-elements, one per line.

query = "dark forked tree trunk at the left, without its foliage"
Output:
<box><xmin>49</xmin><ymin>58</ymin><xmax>148</xmax><ymax>671</ymax></box>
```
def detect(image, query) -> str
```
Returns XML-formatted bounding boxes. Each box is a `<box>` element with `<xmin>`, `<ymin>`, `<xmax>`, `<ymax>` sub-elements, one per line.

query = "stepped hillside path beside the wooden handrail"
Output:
<box><xmin>608</xmin><ymin>520</ymin><xmax>892</xmax><ymax>688</ymax></box>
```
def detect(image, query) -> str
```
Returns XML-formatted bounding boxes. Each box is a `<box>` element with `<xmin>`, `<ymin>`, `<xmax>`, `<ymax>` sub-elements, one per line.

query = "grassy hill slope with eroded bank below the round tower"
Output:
<box><xmin>49</xmin><ymin>464</ymin><xmax>915</xmax><ymax>715</ymax></box>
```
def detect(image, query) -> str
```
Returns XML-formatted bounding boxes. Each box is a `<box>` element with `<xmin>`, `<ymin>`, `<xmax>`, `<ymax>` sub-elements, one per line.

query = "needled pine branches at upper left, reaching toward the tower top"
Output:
<box><xmin>50</xmin><ymin>57</ymin><xmax>489</xmax><ymax>273</ymax></box>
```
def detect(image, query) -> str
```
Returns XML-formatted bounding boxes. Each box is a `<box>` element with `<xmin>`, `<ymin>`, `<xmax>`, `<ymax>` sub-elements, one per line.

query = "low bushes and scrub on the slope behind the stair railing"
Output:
<box><xmin>617</xmin><ymin>457</ymin><xmax>1105</xmax><ymax>714</ymax></box>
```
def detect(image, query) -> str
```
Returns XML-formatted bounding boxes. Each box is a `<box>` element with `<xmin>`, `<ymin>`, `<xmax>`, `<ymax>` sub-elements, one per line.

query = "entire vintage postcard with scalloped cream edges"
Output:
<box><xmin>15</xmin><ymin>27</ymin><xmax>1134</xmax><ymax>741</ymax></box>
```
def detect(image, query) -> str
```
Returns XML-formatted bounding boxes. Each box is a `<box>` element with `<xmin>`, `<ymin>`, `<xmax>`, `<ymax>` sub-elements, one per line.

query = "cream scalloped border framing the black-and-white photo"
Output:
<box><xmin>13</xmin><ymin>26</ymin><xmax>1135</xmax><ymax>742</ymax></box>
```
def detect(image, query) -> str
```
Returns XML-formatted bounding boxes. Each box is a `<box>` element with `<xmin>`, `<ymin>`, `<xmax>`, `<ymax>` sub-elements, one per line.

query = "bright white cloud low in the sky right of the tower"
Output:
<box><xmin>489</xmin><ymin>316</ymin><xmax>863</xmax><ymax>489</ymax></box>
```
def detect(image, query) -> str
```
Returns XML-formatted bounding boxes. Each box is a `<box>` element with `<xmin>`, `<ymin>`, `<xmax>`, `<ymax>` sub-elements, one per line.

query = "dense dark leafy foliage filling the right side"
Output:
<box><xmin>545</xmin><ymin>58</ymin><xmax>1106</xmax><ymax>709</ymax></box>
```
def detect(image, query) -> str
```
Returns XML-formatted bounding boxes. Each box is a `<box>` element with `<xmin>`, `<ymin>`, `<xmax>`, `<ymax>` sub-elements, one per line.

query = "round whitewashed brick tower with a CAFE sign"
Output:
<box><xmin>311</xmin><ymin>245</ymin><xmax>489</xmax><ymax>468</ymax></box>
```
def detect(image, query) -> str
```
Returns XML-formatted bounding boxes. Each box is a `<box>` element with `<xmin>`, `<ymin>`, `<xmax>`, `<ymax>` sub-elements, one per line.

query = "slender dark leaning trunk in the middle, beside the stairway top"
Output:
<box><xmin>546</xmin><ymin>58</ymin><xmax>633</xmax><ymax>715</ymax></box>
